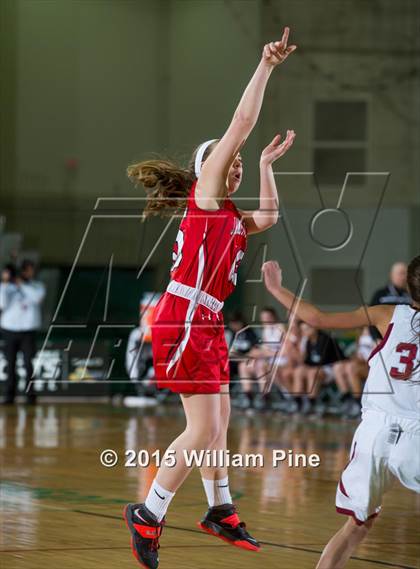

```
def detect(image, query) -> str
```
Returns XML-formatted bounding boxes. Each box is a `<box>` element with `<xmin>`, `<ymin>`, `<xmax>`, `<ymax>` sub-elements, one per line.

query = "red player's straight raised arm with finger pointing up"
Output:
<box><xmin>196</xmin><ymin>28</ymin><xmax>296</xmax><ymax>209</ymax></box>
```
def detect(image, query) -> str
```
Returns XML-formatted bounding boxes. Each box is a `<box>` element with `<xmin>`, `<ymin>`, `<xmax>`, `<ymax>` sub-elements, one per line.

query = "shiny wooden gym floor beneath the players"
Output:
<box><xmin>0</xmin><ymin>403</ymin><xmax>420</xmax><ymax>569</ymax></box>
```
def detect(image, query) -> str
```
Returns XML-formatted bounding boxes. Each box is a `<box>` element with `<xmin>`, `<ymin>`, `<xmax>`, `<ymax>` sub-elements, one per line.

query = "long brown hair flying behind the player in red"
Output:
<box><xmin>127</xmin><ymin>141</ymin><xmax>217</xmax><ymax>218</ymax></box>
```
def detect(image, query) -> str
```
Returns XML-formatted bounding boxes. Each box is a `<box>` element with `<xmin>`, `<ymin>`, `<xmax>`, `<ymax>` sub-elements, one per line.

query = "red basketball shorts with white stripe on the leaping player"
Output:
<box><xmin>152</xmin><ymin>292</ymin><xmax>229</xmax><ymax>393</ymax></box>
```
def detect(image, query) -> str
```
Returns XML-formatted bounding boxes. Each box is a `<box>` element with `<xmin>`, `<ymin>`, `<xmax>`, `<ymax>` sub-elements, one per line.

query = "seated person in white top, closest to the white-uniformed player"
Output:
<box><xmin>333</xmin><ymin>327</ymin><xmax>376</xmax><ymax>419</ymax></box>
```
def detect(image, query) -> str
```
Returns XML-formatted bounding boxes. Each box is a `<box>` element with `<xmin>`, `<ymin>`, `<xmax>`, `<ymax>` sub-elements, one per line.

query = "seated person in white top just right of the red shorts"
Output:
<box><xmin>235</xmin><ymin>307</ymin><xmax>284</xmax><ymax>409</ymax></box>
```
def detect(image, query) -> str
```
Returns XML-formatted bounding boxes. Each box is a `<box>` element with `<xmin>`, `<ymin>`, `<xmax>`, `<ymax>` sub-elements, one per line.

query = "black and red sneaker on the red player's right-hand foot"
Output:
<box><xmin>198</xmin><ymin>504</ymin><xmax>261</xmax><ymax>551</ymax></box>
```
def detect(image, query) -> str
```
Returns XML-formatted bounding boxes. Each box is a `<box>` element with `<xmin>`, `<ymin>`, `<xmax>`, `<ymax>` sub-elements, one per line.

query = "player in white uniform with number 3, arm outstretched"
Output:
<box><xmin>262</xmin><ymin>255</ymin><xmax>420</xmax><ymax>569</ymax></box>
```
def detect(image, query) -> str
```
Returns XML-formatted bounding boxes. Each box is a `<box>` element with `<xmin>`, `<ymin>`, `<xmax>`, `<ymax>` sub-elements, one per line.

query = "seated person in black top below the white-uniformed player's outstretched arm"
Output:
<box><xmin>293</xmin><ymin>322</ymin><xmax>345</xmax><ymax>415</ymax></box>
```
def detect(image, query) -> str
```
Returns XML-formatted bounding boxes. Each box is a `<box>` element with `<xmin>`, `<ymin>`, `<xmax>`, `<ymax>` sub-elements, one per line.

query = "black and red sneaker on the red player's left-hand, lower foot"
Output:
<box><xmin>124</xmin><ymin>504</ymin><xmax>164</xmax><ymax>569</ymax></box>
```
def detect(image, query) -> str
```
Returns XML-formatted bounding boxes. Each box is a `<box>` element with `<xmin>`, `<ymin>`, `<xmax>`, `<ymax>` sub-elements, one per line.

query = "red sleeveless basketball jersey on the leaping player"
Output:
<box><xmin>171</xmin><ymin>182</ymin><xmax>247</xmax><ymax>302</ymax></box>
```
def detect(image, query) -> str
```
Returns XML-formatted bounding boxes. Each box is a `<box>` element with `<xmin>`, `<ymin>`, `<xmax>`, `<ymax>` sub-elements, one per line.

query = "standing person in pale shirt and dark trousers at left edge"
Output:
<box><xmin>0</xmin><ymin>260</ymin><xmax>45</xmax><ymax>403</ymax></box>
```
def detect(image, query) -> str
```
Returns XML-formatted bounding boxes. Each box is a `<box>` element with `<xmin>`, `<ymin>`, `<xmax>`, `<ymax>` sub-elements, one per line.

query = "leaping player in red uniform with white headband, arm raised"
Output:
<box><xmin>124</xmin><ymin>28</ymin><xmax>296</xmax><ymax>569</ymax></box>
